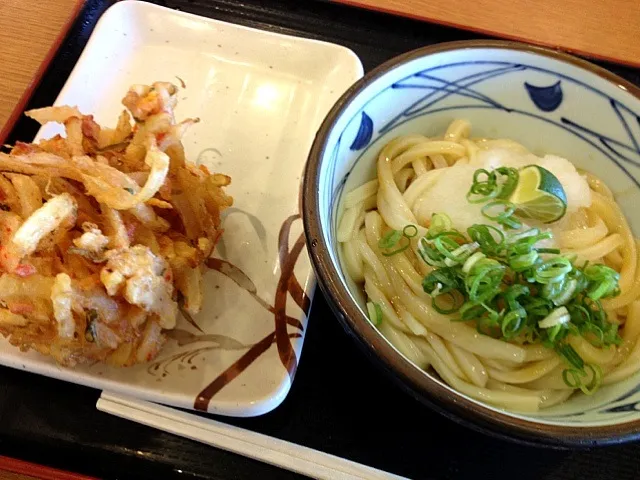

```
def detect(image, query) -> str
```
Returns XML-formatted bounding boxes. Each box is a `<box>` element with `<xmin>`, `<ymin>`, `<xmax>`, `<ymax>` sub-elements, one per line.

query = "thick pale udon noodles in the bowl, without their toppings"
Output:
<box><xmin>337</xmin><ymin>120</ymin><xmax>640</xmax><ymax>412</ymax></box>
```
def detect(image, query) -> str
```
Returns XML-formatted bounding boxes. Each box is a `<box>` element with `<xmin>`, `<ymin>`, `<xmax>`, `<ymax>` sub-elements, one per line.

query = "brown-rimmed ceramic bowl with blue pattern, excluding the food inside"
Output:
<box><xmin>303</xmin><ymin>41</ymin><xmax>640</xmax><ymax>446</ymax></box>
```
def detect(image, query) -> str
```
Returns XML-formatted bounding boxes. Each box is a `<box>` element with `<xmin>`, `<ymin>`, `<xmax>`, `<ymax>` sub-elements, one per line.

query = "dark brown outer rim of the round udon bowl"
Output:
<box><xmin>301</xmin><ymin>40</ymin><xmax>640</xmax><ymax>448</ymax></box>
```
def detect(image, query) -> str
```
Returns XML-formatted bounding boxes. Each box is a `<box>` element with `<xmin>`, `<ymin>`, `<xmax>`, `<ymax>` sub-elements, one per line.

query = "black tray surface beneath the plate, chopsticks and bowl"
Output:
<box><xmin>0</xmin><ymin>0</ymin><xmax>640</xmax><ymax>480</ymax></box>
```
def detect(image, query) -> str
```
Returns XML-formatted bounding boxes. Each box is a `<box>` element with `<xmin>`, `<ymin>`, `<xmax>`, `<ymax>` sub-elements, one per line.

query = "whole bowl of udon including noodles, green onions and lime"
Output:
<box><xmin>302</xmin><ymin>41</ymin><xmax>640</xmax><ymax>447</ymax></box>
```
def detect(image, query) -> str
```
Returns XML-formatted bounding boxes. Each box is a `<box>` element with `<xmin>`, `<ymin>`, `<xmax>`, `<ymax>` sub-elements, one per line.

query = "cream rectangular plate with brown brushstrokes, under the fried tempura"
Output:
<box><xmin>0</xmin><ymin>1</ymin><xmax>362</xmax><ymax>416</ymax></box>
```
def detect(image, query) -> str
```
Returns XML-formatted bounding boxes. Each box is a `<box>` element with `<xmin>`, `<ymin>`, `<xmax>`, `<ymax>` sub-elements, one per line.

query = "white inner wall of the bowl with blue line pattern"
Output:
<box><xmin>319</xmin><ymin>48</ymin><xmax>640</xmax><ymax>426</ymax></box>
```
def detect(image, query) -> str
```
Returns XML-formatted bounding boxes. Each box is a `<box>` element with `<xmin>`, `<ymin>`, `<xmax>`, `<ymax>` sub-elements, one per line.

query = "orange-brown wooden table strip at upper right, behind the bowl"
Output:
<box><xmin>334</xmin><ymin>0</ymin><xmax>640</xmax><ymax>67</ymax></box>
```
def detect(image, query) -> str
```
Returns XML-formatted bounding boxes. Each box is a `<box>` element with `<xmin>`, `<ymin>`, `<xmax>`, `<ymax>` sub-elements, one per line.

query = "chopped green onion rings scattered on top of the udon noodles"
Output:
<box><xmin>408</xmin><ymin>206</ymin><xmax>621</xmax><ymax>386</ymax></box>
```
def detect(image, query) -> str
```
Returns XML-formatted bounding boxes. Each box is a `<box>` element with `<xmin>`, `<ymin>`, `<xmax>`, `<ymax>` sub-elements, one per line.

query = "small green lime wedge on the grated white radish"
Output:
<box><xmin>509</xmin><ymin>165</ymin><xmax>567</xmax><ymax>223</ymax></box>
